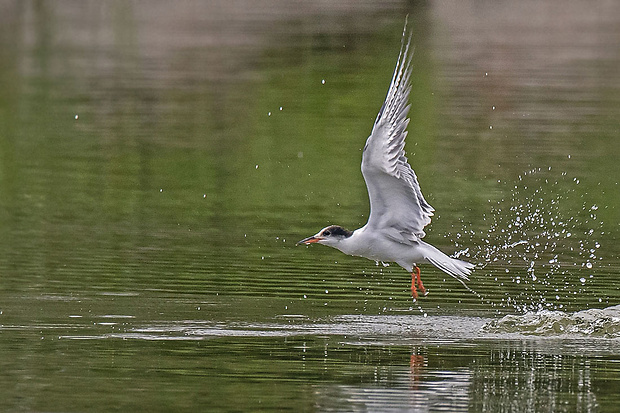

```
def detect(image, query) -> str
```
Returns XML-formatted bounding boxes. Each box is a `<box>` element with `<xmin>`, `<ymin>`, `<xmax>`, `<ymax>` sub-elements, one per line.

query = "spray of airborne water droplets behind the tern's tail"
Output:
<box><xmin>453</xmin><ymin>167</ymin><xmax>606</xmax><ymax>311</ymax></box>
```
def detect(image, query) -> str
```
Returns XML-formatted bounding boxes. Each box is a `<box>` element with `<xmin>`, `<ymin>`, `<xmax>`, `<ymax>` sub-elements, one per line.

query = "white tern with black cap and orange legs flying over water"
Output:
<box><xmin>297</xmin><ymin>21</ymin><xmax>474</xmax><ymax>299</ymax></box>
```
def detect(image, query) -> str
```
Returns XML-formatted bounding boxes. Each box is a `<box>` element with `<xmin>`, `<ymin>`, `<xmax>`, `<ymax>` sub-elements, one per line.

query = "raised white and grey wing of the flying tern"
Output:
<box><xmin>362</xmin><ymin>22</ymin><xmax>434</xmax><ymax>244</ymax></box>
